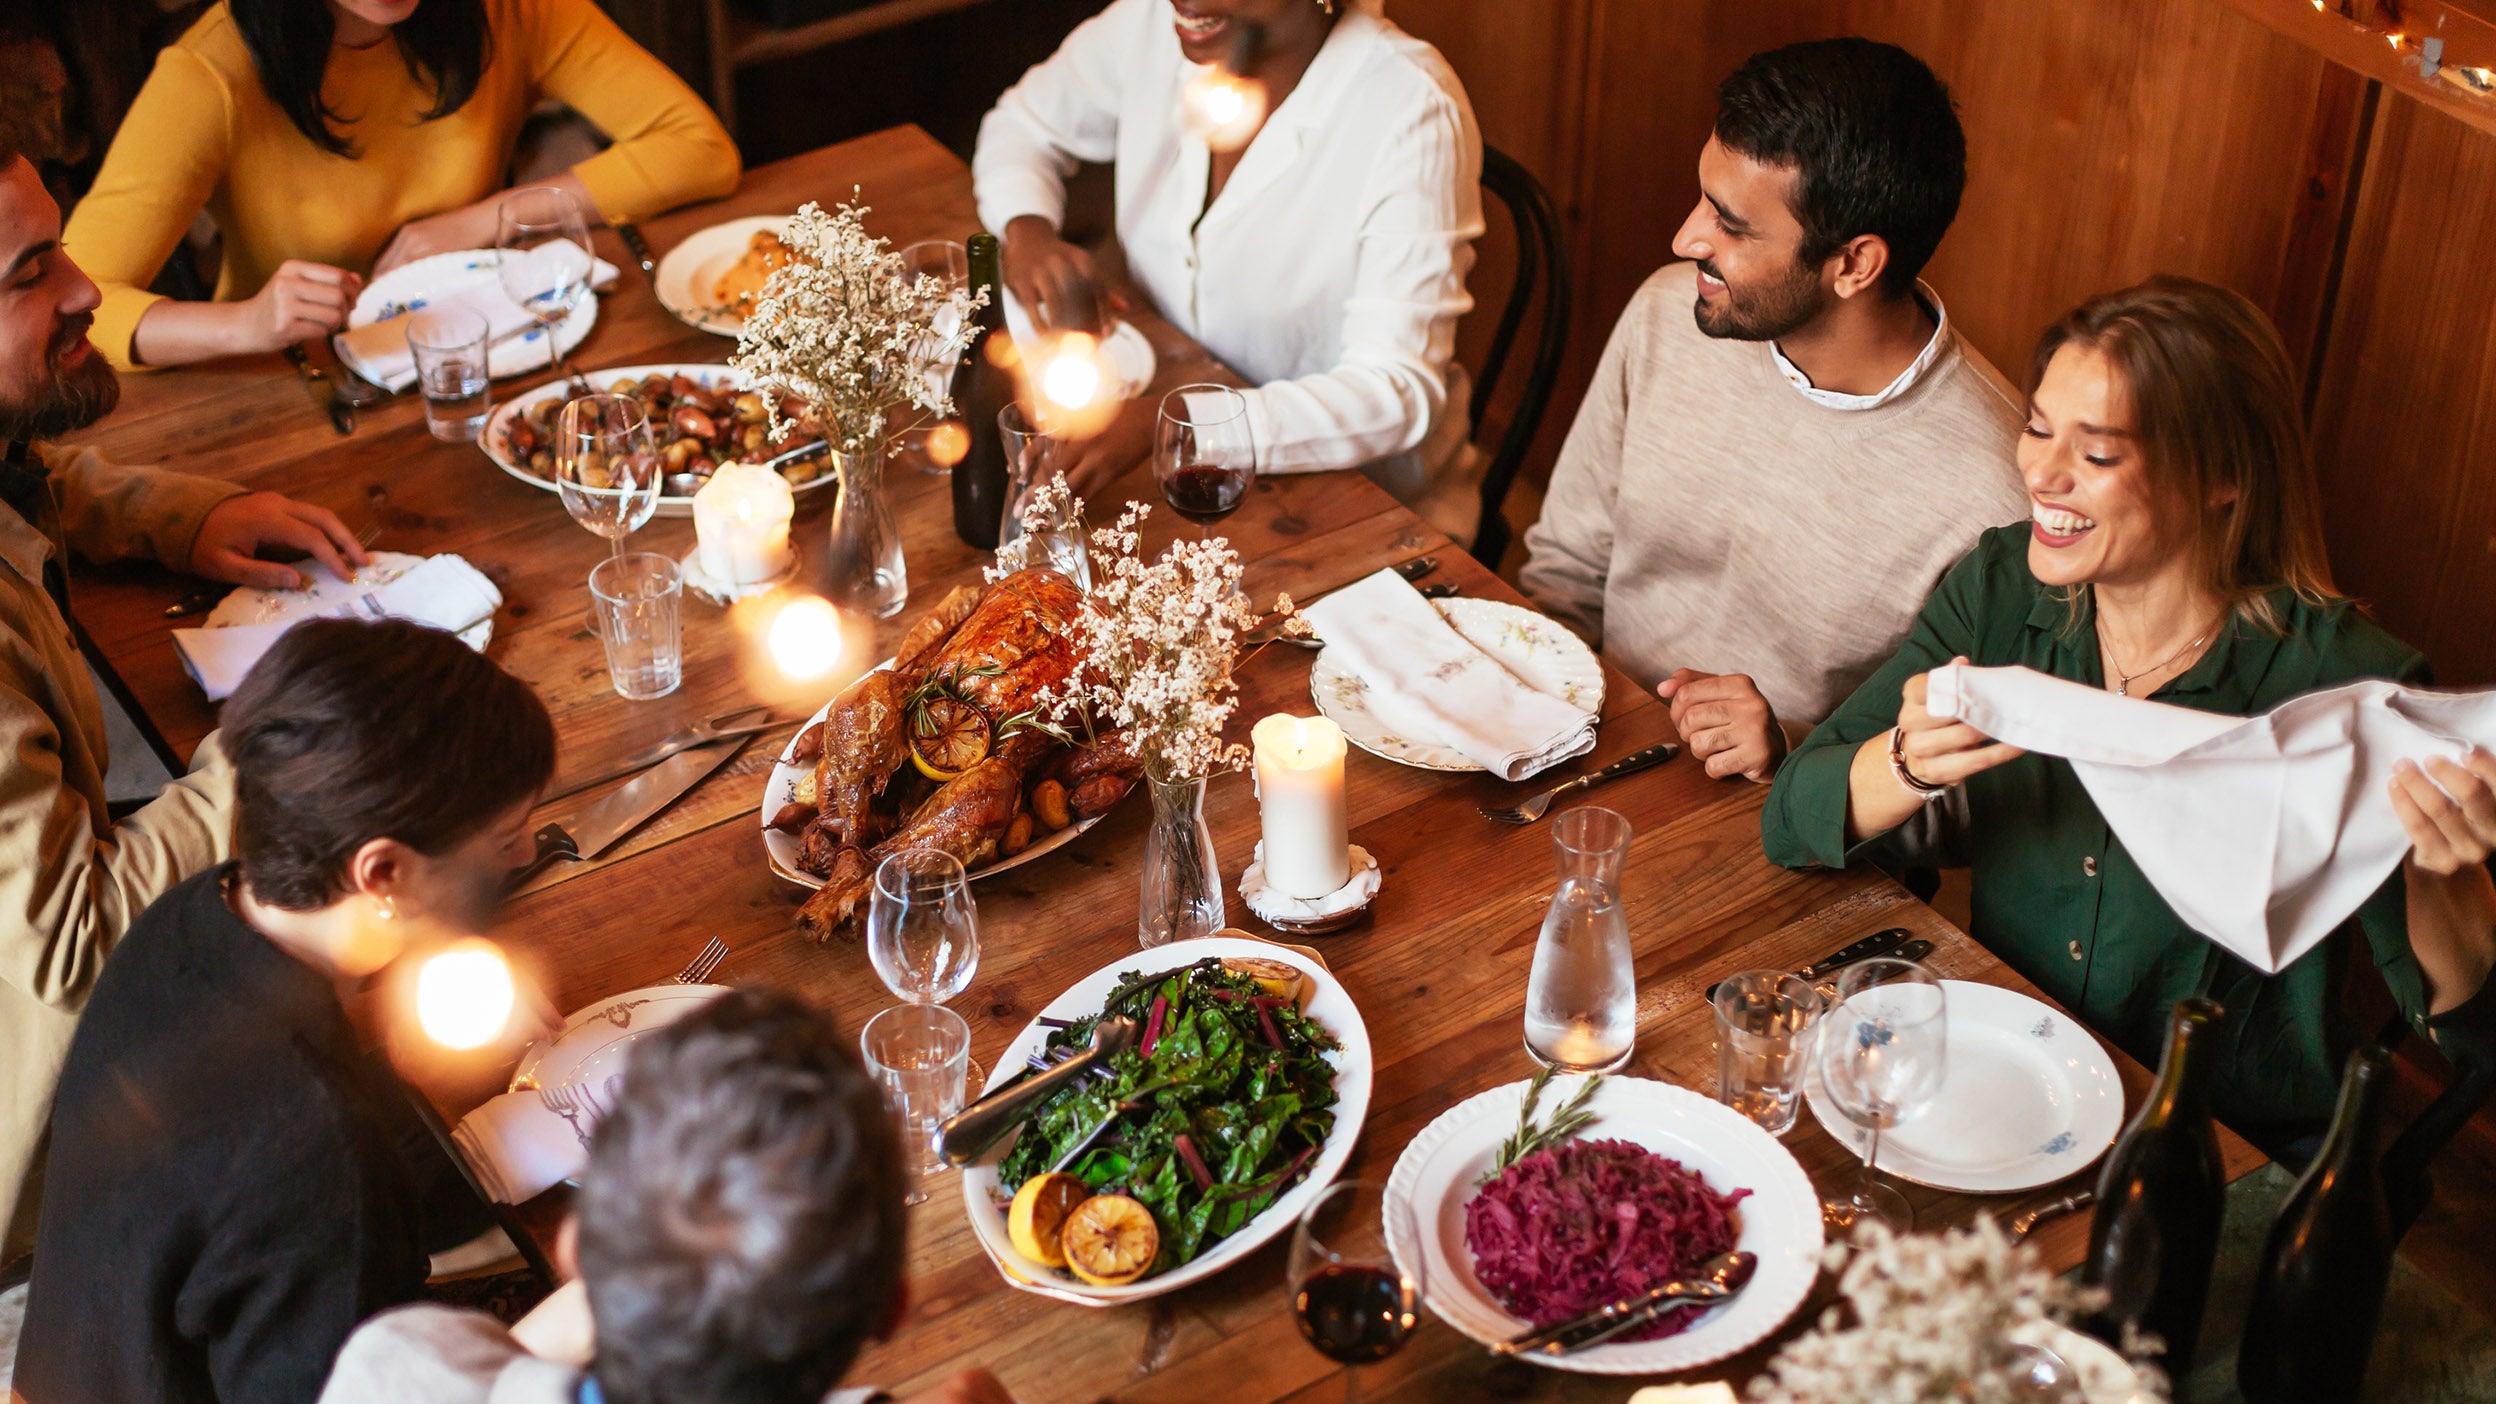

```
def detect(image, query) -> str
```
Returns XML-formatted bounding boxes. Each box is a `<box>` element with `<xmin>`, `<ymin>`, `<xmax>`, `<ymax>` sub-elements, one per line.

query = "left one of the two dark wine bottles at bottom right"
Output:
<box><xmin>2082</xmin><ymin>999</ymin><xmax>2226</xmax><ymax>1377</ymax></box>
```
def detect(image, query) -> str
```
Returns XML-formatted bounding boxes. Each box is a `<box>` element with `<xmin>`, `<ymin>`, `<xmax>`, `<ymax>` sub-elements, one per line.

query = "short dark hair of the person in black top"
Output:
<box><xmin>225</xmin><ymin>620</ymin><xmax>554</xmax><ymax>912</ymax></box>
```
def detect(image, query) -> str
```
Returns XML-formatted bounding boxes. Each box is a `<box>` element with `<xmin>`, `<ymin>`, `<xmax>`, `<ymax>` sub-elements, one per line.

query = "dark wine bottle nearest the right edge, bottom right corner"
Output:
<box><xmin>2236</xmin><ymin>1047</ymin><xmax>2399</xmax><ymax>1404</ymax></box>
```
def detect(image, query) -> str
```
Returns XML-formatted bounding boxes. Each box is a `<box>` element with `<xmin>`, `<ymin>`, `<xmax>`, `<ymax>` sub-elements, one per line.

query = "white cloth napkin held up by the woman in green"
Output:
<box><xmin>1924</xmin><ymin>665</ymin><xmax>2496</xmax><ymax>972</ymax></box>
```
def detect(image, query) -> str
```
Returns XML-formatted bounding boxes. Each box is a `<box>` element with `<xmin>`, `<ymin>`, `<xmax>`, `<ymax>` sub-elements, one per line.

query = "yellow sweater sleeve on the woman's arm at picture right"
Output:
<box><xmin>522</xmin><ymin>0</ymin><xmax>744</xmax><ymax>220</ymax></box>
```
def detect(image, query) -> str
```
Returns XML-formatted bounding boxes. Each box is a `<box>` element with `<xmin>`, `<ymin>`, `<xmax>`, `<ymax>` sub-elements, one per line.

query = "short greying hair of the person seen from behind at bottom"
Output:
<box><xmin>579</xmin><ymin>989</ymin><xmax>904</xmax><ymax>1404</ymax></box>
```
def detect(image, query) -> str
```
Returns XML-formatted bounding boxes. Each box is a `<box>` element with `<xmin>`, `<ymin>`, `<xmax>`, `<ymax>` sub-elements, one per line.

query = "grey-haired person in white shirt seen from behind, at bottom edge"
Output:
<box><xmin>322</xmin><ymin>989</ymin><xmax>1013</xmax><ymax>1404</ymax></box>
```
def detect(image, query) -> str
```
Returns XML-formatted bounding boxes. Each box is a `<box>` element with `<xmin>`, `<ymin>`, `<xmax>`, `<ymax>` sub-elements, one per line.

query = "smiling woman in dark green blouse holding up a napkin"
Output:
<box><xmin>1762</xmin><ymin>277</ymin><xmax>2496</xmax><ymax>1144</ymax></box>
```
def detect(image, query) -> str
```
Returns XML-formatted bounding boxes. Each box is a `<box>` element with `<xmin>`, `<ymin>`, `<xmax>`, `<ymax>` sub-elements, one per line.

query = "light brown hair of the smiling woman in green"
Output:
<box><xmin>2029</xmin><ymin>275</ymin><xmax>2339</xmax><ymax>632</ymax></box>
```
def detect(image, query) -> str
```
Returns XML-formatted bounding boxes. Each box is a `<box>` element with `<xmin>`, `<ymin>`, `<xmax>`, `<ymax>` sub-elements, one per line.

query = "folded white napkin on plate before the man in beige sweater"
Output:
<box><xmin>1303</xmin><ymin>570</ymin><xmax>1595</xmax><ymax>779</ymax></box>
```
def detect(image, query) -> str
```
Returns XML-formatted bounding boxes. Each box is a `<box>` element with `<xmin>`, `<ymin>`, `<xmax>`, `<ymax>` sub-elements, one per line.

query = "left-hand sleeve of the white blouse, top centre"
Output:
<box><xmin>971</xmin><ymin>0</ymin><xmax>1153</xmax><ymax>235</ymax></box>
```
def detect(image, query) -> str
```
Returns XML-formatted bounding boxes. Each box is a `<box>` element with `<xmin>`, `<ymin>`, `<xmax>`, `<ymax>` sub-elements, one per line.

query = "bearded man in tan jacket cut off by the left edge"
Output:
<box><xmin>0</xmin><ymin>142</ymin><xmax>364</xmax><ymax>1259</ymax></box>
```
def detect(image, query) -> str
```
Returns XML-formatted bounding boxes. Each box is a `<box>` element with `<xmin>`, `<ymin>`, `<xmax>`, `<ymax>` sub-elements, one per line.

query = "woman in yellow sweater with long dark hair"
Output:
<box><xmin>62</xmin><ymin>0</ymin><xmax>739</xmax><ymax>367</ymax></box>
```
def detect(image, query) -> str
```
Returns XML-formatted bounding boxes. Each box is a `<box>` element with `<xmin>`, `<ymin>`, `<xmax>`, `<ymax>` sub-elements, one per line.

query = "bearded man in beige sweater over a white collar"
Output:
<box><xmin>1523</xmin><ymin>40</ymin><xmax>2027</xmax><ymax>782</ymax></box>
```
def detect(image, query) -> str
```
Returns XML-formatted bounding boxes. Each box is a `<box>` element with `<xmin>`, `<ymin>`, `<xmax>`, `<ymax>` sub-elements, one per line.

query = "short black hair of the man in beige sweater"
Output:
<box><xmin>1715</xmin><ymin>37</ymin><xmax>1967</xmax><ymax>297</ymax></box>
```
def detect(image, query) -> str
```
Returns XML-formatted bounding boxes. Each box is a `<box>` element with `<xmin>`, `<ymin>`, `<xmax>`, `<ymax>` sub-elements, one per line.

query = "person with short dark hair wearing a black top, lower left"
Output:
<box><xmin>15</xmin><ymin>620</ymin><xmax>554</xmax><ymax>1404</ymax></box>
